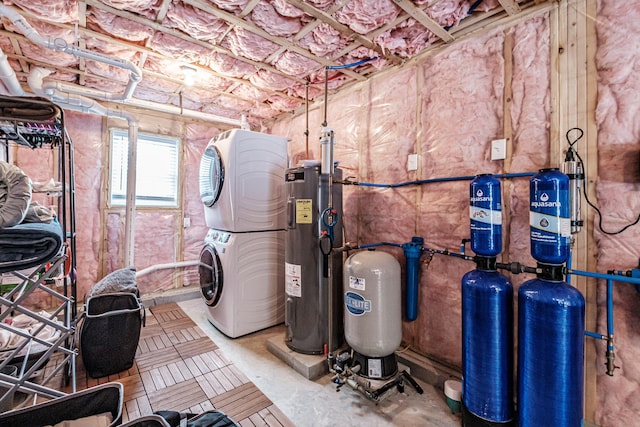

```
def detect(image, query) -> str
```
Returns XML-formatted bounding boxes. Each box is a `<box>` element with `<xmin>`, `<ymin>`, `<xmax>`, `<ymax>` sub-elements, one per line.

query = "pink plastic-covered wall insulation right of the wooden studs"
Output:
<box><xmin>592</xmin><ymin>1</ymin><xmax>640</xmax><ymax>427</ymax></box>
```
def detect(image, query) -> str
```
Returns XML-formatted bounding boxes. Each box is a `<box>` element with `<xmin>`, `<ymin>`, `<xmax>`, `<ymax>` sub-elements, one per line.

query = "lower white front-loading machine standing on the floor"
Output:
<box><xmin>199</xmin><ymin>230</ymin><xmax>285</xmax><ymax>338</ymax></box>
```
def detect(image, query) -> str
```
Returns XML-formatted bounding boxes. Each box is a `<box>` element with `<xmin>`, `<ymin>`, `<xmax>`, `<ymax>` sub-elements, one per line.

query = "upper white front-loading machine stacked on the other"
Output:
<box><xmin>199</xmin><ymin>129</ymin><xmax>287</xmax><ymax>232</ymax></box>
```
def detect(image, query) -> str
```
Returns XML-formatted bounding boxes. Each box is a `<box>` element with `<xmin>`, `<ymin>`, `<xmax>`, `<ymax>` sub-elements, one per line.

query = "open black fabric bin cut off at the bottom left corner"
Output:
<box><xmin>0</xmin><ymin>382</ymin><xmax>124</xmax><ymax>427</ymax></box>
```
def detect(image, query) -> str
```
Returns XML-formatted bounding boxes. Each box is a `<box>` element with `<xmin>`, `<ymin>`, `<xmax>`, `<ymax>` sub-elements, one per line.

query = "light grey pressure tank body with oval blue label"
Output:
<box><xmin>344</xmin><ymin>250</ymin><xmax>402</xmax><ymax>358</ymax></box>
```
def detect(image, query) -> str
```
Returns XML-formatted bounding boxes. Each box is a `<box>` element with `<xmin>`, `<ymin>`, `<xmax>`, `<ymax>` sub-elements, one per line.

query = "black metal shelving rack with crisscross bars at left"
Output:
<box><xmin>0</xmin><ymin>95</ymin><xmax>78</xmax><ymax>405</ymax></box>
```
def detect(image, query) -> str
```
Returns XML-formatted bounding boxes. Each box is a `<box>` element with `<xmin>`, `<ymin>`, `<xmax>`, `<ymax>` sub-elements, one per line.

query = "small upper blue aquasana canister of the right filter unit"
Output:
<box><xmin>529</xmin><ymin>168</ymin><xmax>571</xmax><ymax>265</ymax></box>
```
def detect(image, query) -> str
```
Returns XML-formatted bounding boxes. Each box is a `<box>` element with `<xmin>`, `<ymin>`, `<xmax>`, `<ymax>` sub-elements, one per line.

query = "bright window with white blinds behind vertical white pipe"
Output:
<box><xmin>109</xmin><ymin>129</ymin><xmax>180</xmax><ymax>207</ymax></box>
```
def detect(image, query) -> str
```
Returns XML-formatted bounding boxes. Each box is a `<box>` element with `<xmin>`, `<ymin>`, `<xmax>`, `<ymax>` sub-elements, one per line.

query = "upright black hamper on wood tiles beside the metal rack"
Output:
<box><xmin>80</xmin><ymin>292</ymin><xmax>144</xmax><ymax>378</ymax></box>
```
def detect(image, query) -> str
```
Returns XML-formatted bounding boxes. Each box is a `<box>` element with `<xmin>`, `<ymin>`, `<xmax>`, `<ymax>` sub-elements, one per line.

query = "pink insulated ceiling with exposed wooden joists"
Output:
<box><xmin>0</xmin><ymin>0</ymin><xmax>552</xmax><ymax>123</ymax></box>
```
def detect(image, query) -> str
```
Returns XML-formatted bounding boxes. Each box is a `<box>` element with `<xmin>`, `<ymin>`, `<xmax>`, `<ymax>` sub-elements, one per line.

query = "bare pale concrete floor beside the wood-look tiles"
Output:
<box><xmin>178</xmin><ymin>298</ymin><xmax>461</xmax><ymax>427</ymax></box>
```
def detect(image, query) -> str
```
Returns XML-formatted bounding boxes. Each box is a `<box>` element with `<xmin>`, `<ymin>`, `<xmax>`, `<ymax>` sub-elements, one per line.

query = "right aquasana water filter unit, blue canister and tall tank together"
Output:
<box><xmin>518</xmin><ymin>169</ymin><xmax>585</xmax><ymax>427</ymax></box>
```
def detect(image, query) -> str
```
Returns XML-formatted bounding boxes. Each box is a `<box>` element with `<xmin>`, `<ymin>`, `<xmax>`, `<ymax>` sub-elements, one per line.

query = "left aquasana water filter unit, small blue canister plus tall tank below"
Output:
<box><xmin>462</xmin><ymin>175</ymin><xmax>514</xmax><ymax>427</ymax></box>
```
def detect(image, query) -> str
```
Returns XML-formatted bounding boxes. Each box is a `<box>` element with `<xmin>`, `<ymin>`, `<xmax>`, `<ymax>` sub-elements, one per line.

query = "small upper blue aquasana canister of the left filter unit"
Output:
<box><xmin>469</xmin><ymin>174</ymin><xmax>502</xmax><ymax>257</ymax></box>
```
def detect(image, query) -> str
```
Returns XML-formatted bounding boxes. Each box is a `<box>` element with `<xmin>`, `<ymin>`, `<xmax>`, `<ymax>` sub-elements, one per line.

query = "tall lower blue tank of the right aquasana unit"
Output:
<box><xmin>518</xmin><ymin>278</ymin><xmax>585</xmax><ymax>427</ymax></box>
